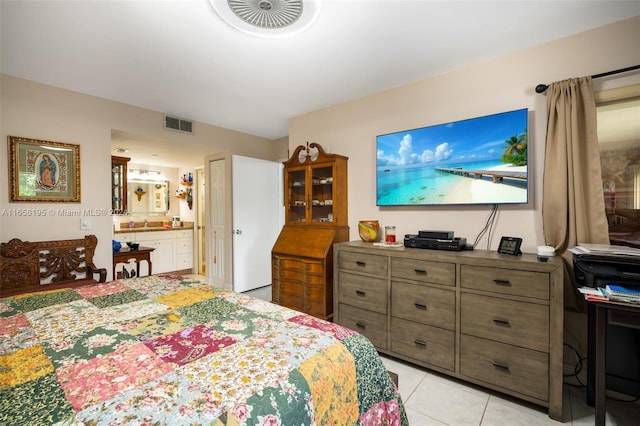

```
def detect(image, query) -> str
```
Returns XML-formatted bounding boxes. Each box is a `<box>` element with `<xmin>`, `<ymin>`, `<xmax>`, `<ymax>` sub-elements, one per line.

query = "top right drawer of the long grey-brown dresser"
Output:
<box><xmin>460</xmin><ymin>265</ymin><xmax>549</xmax><ymax>300</ymax></box>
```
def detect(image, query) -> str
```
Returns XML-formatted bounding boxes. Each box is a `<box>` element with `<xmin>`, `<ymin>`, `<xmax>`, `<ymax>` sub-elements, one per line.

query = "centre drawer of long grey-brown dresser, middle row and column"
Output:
<box><xmin>391</xmin><ymin>281</ymin><xmax>456</xmax><ymax>330</ymax></box>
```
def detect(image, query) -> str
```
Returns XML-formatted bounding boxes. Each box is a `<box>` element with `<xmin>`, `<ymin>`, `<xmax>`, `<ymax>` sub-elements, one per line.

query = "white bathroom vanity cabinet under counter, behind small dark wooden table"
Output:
<box><xmin>113</xmin><ymin>229</ymin><xmax>193</xmax><ymax>276</ymax></box>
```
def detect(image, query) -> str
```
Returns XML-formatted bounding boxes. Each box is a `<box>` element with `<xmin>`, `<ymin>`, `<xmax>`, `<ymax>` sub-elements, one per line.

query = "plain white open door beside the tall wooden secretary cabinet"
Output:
<box><xmin>232</xmin><ymin>155</ymin><xmax>284</xmax><ymax>291</ymax></box>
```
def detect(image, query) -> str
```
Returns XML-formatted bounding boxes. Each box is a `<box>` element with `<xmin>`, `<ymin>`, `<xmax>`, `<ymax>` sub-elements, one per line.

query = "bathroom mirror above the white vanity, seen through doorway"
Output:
<box><xmin>127</xmin><ymin>179</ymin><xmax>170</xmax><ymax>215</ymax></box>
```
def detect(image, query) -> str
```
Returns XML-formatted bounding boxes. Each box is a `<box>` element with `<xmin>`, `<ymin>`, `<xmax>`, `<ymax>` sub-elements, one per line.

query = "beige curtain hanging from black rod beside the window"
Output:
<box><xmin>542</xmin><ymin>77</ymin><xmax>609</xmax><ymax>310</ymax></box>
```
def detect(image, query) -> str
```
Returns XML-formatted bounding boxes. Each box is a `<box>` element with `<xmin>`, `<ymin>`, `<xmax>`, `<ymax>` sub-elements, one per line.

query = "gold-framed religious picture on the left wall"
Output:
<box><xmin>8</xmin><ymin>136</ymin><xmax>80</xmax><ymax>203</ymax></box>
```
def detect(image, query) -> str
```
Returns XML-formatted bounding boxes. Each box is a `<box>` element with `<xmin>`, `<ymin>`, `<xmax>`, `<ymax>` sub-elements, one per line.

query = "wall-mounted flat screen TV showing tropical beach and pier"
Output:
<box><xmin>376</xmin><ymin>108</ymin><xmax>529</xmax><ymax>206</ymax></box>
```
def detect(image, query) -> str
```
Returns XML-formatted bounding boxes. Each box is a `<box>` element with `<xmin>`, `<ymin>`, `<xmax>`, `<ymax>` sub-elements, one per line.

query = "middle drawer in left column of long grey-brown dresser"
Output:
<box><xmin>338</xmin><ymin>271</ymin><xmax>387</xmax><ymax>314</ymax></box>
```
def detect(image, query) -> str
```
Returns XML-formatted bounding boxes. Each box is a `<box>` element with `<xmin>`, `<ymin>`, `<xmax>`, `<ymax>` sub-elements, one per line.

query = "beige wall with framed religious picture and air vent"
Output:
<box><xmin>0</xmin><ymin>75</ymin><xmax>287</xmax><ymax>275</ymax></box>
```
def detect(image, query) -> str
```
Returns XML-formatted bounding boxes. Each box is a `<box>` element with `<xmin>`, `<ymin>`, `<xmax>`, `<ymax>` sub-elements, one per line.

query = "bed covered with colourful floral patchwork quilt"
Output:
<box><xmin>0</xmin><ymin>275</ymin><xmax>408</xmax><ymax>426</ymax></box>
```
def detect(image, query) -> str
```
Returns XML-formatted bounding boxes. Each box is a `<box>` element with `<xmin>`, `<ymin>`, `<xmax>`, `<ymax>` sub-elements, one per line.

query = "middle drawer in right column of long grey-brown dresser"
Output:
<box><xmin>460</xmin><ymin>293</ymin><xmax>549</xmax><ymax>352</ymax></box>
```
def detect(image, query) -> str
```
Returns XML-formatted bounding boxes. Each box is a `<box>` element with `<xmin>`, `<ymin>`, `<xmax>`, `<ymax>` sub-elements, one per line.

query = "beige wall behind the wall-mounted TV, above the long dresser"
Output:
<box><xmin>289</xmin><ymin>18</ymin><xmax>640</xmax><ymax>252</ymax></box>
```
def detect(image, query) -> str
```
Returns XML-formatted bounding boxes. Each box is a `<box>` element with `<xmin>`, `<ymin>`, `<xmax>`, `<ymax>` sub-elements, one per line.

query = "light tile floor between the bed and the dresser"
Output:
<box><xmin>226</xmin><ymin>286</ymin><xmax>640</xmax><ymax>426</ymax></box>
